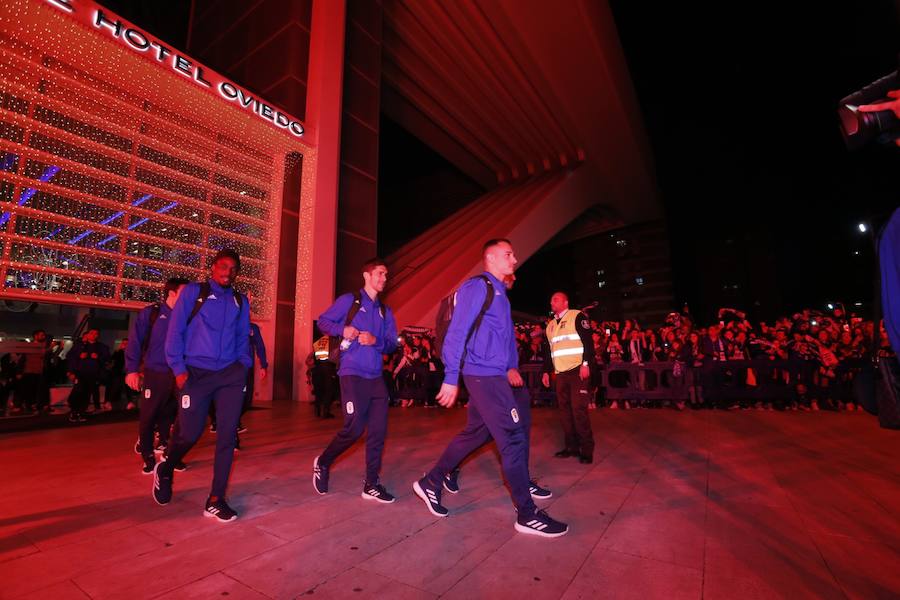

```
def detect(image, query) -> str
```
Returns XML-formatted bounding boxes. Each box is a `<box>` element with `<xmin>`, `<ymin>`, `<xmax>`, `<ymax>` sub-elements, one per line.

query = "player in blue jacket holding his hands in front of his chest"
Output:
<box><xmin>313</xmin><ymin>258</ymin><xmax>397</xmax><ymax>503</ymax></box>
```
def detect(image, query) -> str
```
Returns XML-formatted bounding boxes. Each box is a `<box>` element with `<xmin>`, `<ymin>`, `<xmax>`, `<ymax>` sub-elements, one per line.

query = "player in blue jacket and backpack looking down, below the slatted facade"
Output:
<box><xmin>153</xmin><ymin>249</ymin><xmax>251</xmax><ymax>521</ymax></box>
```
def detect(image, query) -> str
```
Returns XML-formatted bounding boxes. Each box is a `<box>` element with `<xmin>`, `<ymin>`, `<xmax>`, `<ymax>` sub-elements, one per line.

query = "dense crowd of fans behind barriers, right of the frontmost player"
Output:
<box><xmin>517</xmin><ymin>306</ymin><xmax>892</xmax><ymax>411</ymax></box>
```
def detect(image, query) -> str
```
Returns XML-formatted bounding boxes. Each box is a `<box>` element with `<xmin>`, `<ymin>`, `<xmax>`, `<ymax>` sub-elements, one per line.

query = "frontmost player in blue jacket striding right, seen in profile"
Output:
<box><xmin>413</xmin><ymin>239</ymin><xmax>569</xmax><ymax>537</ymax></box>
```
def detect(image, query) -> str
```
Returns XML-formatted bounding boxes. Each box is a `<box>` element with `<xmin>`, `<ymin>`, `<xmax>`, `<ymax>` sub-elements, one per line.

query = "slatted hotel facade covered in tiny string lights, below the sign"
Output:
<box><xmin>0</xmin><ymin>0</ymin><xmax>310</xmax><ymax>318</ymax></box>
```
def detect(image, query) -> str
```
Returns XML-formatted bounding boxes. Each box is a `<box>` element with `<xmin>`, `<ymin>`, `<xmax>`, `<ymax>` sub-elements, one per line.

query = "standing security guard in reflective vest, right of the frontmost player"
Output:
<box><xmin>542</xmin><ymin>292</ymin><xmax>594</xmax><ymax>464</ymax></box>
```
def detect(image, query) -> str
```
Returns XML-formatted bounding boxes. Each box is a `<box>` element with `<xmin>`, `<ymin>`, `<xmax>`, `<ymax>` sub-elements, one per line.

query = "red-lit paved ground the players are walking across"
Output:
<box><xmin>0</xmin><ymin>406</ymin><xmax>900</xmax><ymax>600</ymax></box>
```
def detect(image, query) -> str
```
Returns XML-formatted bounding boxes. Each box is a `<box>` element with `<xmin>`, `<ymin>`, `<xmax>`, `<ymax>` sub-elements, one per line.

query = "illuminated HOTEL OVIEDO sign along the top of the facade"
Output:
<box><xmin>46</xmin><ymin>0</ymin><xmax>304</xmax><ymax>137</ymax></box>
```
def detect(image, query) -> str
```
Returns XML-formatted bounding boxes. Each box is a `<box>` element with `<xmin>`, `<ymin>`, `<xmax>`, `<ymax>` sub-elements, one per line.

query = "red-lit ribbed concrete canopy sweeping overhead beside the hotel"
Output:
<box><xmin>382</xmin><ymin>0</ymin><xmax>661</xmax><ymax>325</ymax></box>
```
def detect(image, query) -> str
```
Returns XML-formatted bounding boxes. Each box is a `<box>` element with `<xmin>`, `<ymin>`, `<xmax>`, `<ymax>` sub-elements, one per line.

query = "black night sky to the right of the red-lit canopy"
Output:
<box><xmin>611</xmin><ymin>0</ymin><xmax>900</xmax><ymax>317</ymax></box>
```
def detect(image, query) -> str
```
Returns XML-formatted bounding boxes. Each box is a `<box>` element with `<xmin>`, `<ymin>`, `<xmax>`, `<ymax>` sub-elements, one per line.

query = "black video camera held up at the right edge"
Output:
<box><xmin>838</xmin><ymin>71</ymin><xmax>900</xmax><ymax>150</ymax></box>
